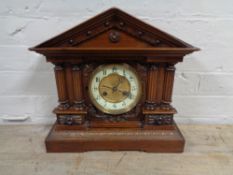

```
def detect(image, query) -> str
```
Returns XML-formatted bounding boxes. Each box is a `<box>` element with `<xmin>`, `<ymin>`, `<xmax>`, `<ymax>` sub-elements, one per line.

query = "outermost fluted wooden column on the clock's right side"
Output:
<box><xmin>162</xmin><ymin>65</ymin><xmax>175</xmax><ymax>109</ymax></box>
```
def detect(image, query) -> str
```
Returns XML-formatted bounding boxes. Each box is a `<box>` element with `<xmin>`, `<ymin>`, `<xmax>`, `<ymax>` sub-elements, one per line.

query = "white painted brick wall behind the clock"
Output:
<box><xmin>0</xmin><ymin>0</ymin><xmax>233</xmax><ymax>123</ymax></box>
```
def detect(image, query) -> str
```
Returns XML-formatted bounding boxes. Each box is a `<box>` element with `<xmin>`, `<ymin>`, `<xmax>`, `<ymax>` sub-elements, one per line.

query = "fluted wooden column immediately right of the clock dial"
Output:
<box><xmin>145</xmin><ymin>64</ymin><xmax>158</xmax><ymax>110</ymax></box>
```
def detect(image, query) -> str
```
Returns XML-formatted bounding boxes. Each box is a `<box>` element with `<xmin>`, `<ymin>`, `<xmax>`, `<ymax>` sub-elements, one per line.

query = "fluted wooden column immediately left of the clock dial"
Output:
<box><xmin>72</xmin><ymin>65</ymin><xmax>85</xmax><ymax>110</ymax></box>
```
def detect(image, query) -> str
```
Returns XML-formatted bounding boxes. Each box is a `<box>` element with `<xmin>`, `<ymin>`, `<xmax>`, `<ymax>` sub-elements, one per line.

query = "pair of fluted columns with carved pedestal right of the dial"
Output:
<box><xmin>142</xmin><ymin>63</ymin><xmax>176</xmax><ymax>128</ymax></box>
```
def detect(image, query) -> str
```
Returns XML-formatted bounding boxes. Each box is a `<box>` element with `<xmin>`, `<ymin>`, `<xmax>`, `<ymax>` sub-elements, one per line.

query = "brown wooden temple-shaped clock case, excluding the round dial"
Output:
<box><xmin>30</xmin><ymin>8</ymin><xmax>199</xmax><ymax>152</ymax></box>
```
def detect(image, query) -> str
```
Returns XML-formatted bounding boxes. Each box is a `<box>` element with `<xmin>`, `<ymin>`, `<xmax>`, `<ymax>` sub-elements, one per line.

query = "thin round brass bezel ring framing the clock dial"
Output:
<box><xmin>88</xmin><ymin>63</ymin><xmax>142</xmax><ymax>115</ymax></box>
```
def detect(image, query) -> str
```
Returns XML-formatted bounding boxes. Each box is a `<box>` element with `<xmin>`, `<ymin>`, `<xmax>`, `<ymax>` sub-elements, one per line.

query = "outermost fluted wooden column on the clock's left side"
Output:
<box><xmin>54</xmin><ymin>65</ymin><xmax>69</xmax><ymax>109</ymax></box>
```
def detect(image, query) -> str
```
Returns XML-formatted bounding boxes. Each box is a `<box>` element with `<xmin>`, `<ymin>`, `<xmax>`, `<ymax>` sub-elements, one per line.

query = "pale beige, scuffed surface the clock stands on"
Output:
<box><xmin>0</xmin><ymin>125</ymin><xmax>233</xmax><ymax>175</ymax></box>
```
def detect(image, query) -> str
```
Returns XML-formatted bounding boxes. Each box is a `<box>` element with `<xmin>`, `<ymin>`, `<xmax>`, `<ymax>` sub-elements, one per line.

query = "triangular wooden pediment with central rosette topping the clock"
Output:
<box><xmin>30</xmin><ymin>8</ymin><xmax>198</xmax><ymax>58</ymax></box>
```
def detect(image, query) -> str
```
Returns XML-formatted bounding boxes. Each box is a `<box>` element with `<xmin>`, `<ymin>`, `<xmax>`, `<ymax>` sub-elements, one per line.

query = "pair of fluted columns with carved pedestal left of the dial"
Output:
<box><xmin>53</xmin><ymin>62</ymin><xmax>87</xmax><ymax>125</ymax></box>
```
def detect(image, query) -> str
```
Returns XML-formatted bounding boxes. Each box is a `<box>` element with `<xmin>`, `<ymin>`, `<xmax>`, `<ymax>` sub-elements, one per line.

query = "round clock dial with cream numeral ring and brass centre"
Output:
<box><xmin>89</xmin><ymin>64</ymin><xmax>141</xmax><ymax>114</ymax></box>
